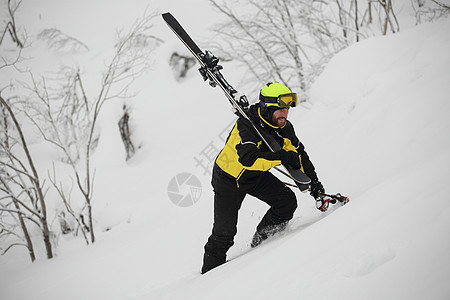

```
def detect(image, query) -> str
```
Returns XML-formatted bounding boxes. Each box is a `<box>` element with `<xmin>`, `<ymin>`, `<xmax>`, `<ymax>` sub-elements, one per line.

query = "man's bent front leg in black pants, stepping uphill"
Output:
<box><xmin>249</xmin><ymin>172</ymin><xmax>297</xmax><ymax>247</ymax></box>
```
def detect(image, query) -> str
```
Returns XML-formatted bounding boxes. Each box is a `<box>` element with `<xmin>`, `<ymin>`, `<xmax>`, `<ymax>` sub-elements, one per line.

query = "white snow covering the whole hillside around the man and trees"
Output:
<box><xmin>0</xmin><ymin>0</ymin><xmax>450</xmax><ymax>300</ymax></box>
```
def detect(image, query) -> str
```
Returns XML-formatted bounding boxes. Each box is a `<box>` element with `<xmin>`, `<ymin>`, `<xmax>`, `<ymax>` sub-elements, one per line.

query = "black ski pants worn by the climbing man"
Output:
<box><xmin>202</xmin><ymin>166</ymin><xmax>297</xmax><ymax>273</ymax></box>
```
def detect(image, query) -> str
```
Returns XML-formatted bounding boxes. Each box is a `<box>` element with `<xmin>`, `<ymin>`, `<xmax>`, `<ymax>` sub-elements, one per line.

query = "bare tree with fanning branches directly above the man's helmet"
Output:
<box><xmin>211</xmin><ymin>0</ymin><xmax>309</xmax><ymax>101</ymax></box>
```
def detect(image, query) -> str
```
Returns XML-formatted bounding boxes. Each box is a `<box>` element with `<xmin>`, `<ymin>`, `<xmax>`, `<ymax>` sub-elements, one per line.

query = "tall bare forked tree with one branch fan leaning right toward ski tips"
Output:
<box><xmin>25</xmin><ymin>11</ymin><xmax>160</xmax><ymax>243</ymax></box>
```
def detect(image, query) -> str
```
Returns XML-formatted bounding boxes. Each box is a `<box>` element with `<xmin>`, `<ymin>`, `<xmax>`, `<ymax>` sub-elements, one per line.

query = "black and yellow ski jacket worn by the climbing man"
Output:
<box><xmin>213</xmin><ymin>104</ymin><xmax>317</xmax><ymax>188</ymax></box>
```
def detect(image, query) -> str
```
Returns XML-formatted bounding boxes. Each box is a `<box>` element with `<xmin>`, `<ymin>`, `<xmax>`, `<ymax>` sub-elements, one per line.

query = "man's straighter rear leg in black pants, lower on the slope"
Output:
<box><xmin>201</xmin><ymin>190</ymin><xmax>245</xmax><ymax>274</ymax></box>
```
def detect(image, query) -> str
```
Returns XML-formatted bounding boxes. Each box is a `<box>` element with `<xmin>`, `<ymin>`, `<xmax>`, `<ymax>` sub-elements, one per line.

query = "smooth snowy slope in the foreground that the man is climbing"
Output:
<box><xmin>134</xmin><ymin>21</ymin><xmax>450</xmax><ymax>299</ymax></box>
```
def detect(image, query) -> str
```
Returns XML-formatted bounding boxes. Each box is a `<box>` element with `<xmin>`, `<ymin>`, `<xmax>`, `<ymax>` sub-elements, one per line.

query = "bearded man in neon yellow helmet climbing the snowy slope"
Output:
<box><xmin>201</xmin><ymin>83</ymin><xmax>325</xmax><ymax>274</ymax></box>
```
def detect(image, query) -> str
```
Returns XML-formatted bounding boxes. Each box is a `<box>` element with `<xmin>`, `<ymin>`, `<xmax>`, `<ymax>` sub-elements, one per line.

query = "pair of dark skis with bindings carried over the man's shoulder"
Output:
<box><xmin>162</xmin><ymin>13</ymin><xmax>311</xmax><ymax>192</ymax></box>
